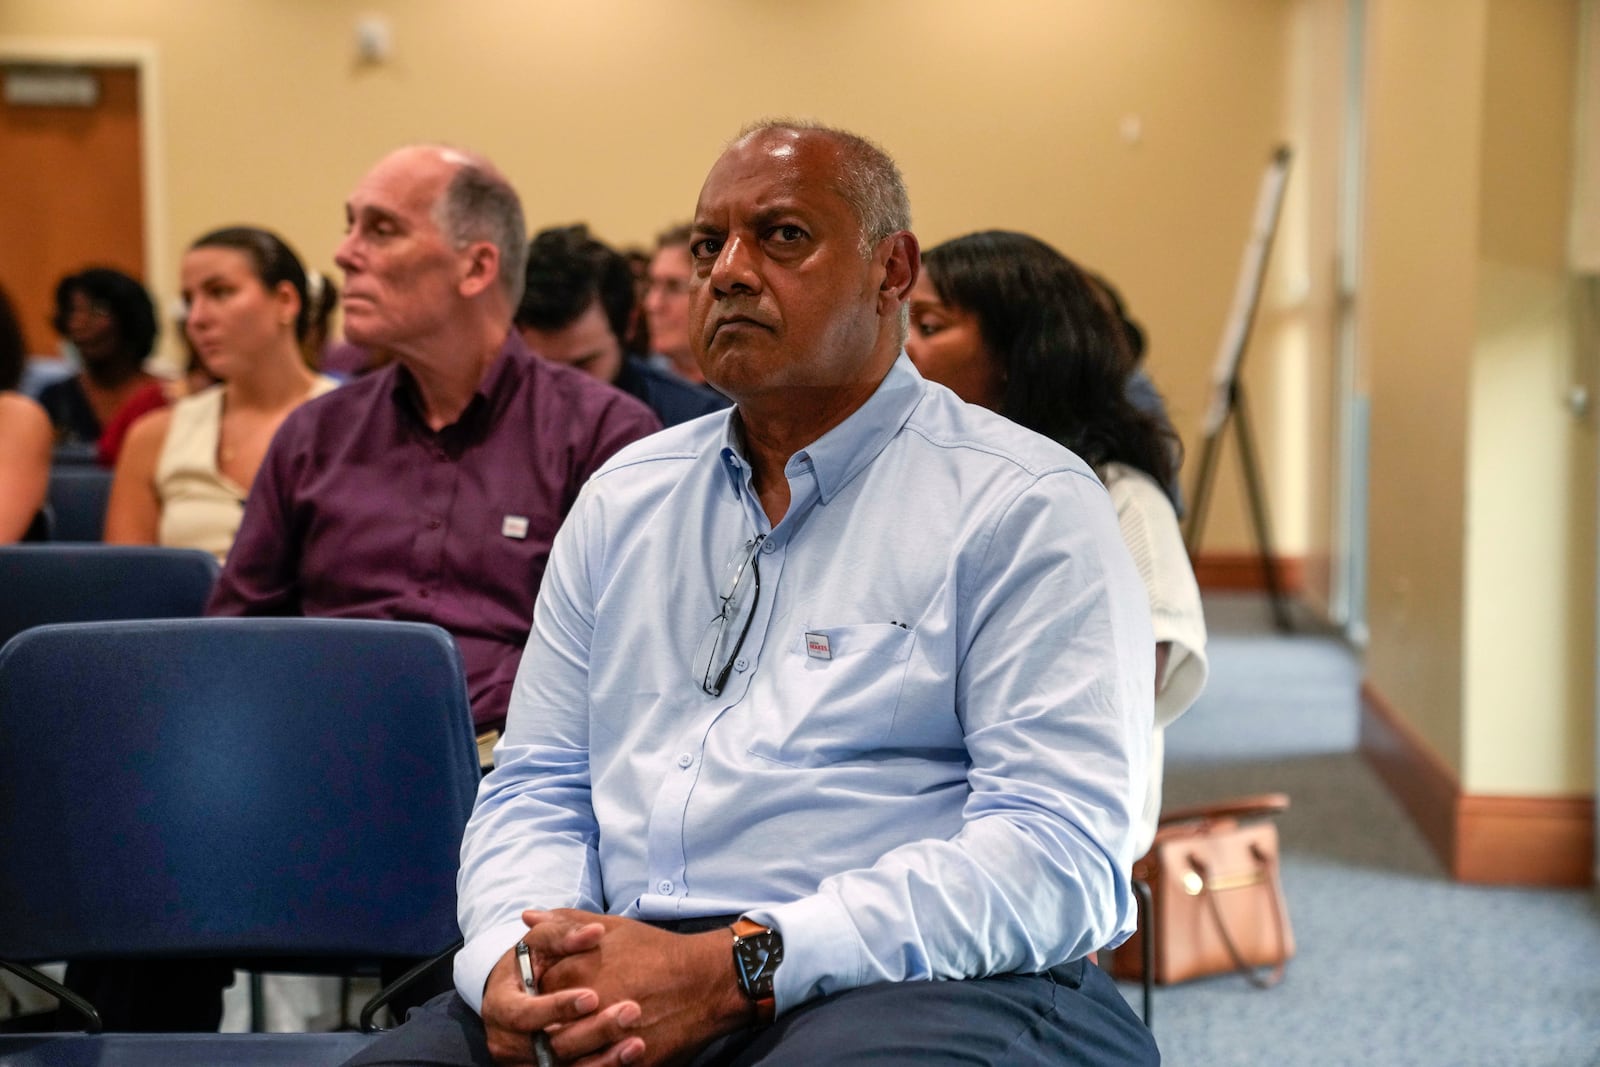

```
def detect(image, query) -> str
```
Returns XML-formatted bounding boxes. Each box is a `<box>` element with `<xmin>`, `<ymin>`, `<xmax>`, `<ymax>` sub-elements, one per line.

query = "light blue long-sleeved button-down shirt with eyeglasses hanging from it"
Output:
<box><xmin>456</xmin><ymin>355</ymin><xmax>1155</xmax><ymax>1013</ymax></box>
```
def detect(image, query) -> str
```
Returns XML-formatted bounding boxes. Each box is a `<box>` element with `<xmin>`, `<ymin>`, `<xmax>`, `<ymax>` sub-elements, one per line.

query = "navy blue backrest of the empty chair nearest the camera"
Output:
<box><xmin>0</xmin><ymin>619</ymin><xmax>480</xmax><ymax>969</ymax></box>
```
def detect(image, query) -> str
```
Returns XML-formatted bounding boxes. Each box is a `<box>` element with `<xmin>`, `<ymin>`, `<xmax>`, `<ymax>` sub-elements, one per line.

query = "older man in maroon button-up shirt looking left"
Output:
<box><xmin>208</xmin><ymin>146</ymin><xmax>661</xmax><ymax>731</ymax></box>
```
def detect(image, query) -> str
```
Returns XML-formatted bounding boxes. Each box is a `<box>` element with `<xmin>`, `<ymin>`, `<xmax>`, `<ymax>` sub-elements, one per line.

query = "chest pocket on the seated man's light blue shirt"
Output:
<box><xmin>749</xmin><ymin>622</ymin><xmax>917</xmax><ymax>766</ymax></box>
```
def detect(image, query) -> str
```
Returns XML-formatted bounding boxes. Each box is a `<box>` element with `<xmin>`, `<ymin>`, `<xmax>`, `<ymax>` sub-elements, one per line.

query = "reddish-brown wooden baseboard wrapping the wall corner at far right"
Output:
<box><xmin>1360</xmin><ymin>681</ymin><xmax>1595</xmax><ymax>886</ymax></box>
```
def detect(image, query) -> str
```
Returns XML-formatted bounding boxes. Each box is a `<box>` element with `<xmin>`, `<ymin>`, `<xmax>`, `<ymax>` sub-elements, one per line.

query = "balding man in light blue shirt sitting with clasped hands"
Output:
<box><xmin>344</xmin><ymin>125</ymin><xmax>1158</xmax><ymax>1067</ymax></box>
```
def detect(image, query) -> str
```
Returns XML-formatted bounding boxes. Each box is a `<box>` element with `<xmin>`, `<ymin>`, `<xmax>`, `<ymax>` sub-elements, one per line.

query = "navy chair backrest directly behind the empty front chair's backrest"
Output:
<box><xmin>0</xmin><ymin>544</ymin><xmax>221</xmax><ymax>645</ymax></box>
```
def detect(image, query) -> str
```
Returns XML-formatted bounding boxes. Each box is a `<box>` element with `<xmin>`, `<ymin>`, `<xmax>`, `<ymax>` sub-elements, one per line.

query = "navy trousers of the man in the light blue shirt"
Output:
<box><xmin>349</xmin><ymin>960</ymin><xmax>1162</xmax><ymax>1067</ymax></box>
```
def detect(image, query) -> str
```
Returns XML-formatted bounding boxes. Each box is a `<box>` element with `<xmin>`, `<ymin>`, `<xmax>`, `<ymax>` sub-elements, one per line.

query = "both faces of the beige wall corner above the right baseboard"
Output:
<box><xmin>1360</xmin><ymin>0</ymin><xmax>1595</xmax><ymax>795</ymax></box>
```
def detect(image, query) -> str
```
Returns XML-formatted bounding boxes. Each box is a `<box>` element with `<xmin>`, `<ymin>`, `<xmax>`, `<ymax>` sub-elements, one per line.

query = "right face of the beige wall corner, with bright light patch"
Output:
<box><xmin>1461</xmin><ymin>0</ymin><xmax>1595</xmax><ymax>793</ymax></box>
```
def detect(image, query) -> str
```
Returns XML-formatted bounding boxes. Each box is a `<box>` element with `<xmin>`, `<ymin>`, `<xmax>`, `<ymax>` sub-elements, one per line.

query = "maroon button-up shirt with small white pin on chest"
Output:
<box><xmin>206</xmin><ymin>333</ymin><xmax>661</xmax><ymax>728</ymax></box>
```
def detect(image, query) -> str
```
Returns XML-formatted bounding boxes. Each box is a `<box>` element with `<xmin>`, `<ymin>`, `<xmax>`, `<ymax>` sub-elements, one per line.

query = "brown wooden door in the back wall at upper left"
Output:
<box><xmin>0</xmin><ymin>64</ymin><xmax>147</xmax><ymax>354</ymax></box>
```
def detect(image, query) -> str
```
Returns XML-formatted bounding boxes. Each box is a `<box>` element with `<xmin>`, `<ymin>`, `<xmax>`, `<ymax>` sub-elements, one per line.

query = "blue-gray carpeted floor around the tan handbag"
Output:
<box><xmin>1122</xmin><ymin>595</ymin><xmax>1600</xmax><ymax>1067</ymax></box>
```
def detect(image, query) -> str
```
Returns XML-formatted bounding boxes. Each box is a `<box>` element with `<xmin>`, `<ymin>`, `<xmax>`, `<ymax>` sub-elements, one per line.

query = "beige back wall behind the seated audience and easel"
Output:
<box><xmin>0</xmin><ymin>0</ymin><xmax>1312</xmax><ymax>552</ymax></box>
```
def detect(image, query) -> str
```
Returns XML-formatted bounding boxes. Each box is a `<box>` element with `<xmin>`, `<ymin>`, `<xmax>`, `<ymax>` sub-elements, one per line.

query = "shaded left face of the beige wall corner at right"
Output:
<box><xmin>1358</xmin><ymin>0</ymin><xmax>1488</xmax><ymax>769</ymax></box>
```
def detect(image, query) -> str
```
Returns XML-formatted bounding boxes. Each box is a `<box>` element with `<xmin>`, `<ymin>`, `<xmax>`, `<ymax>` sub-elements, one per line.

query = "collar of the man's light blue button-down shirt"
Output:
<box><xmin>722</xmin><ymin>350</ymin><xmax>928</xmax><ymax>504</ymax></box>
